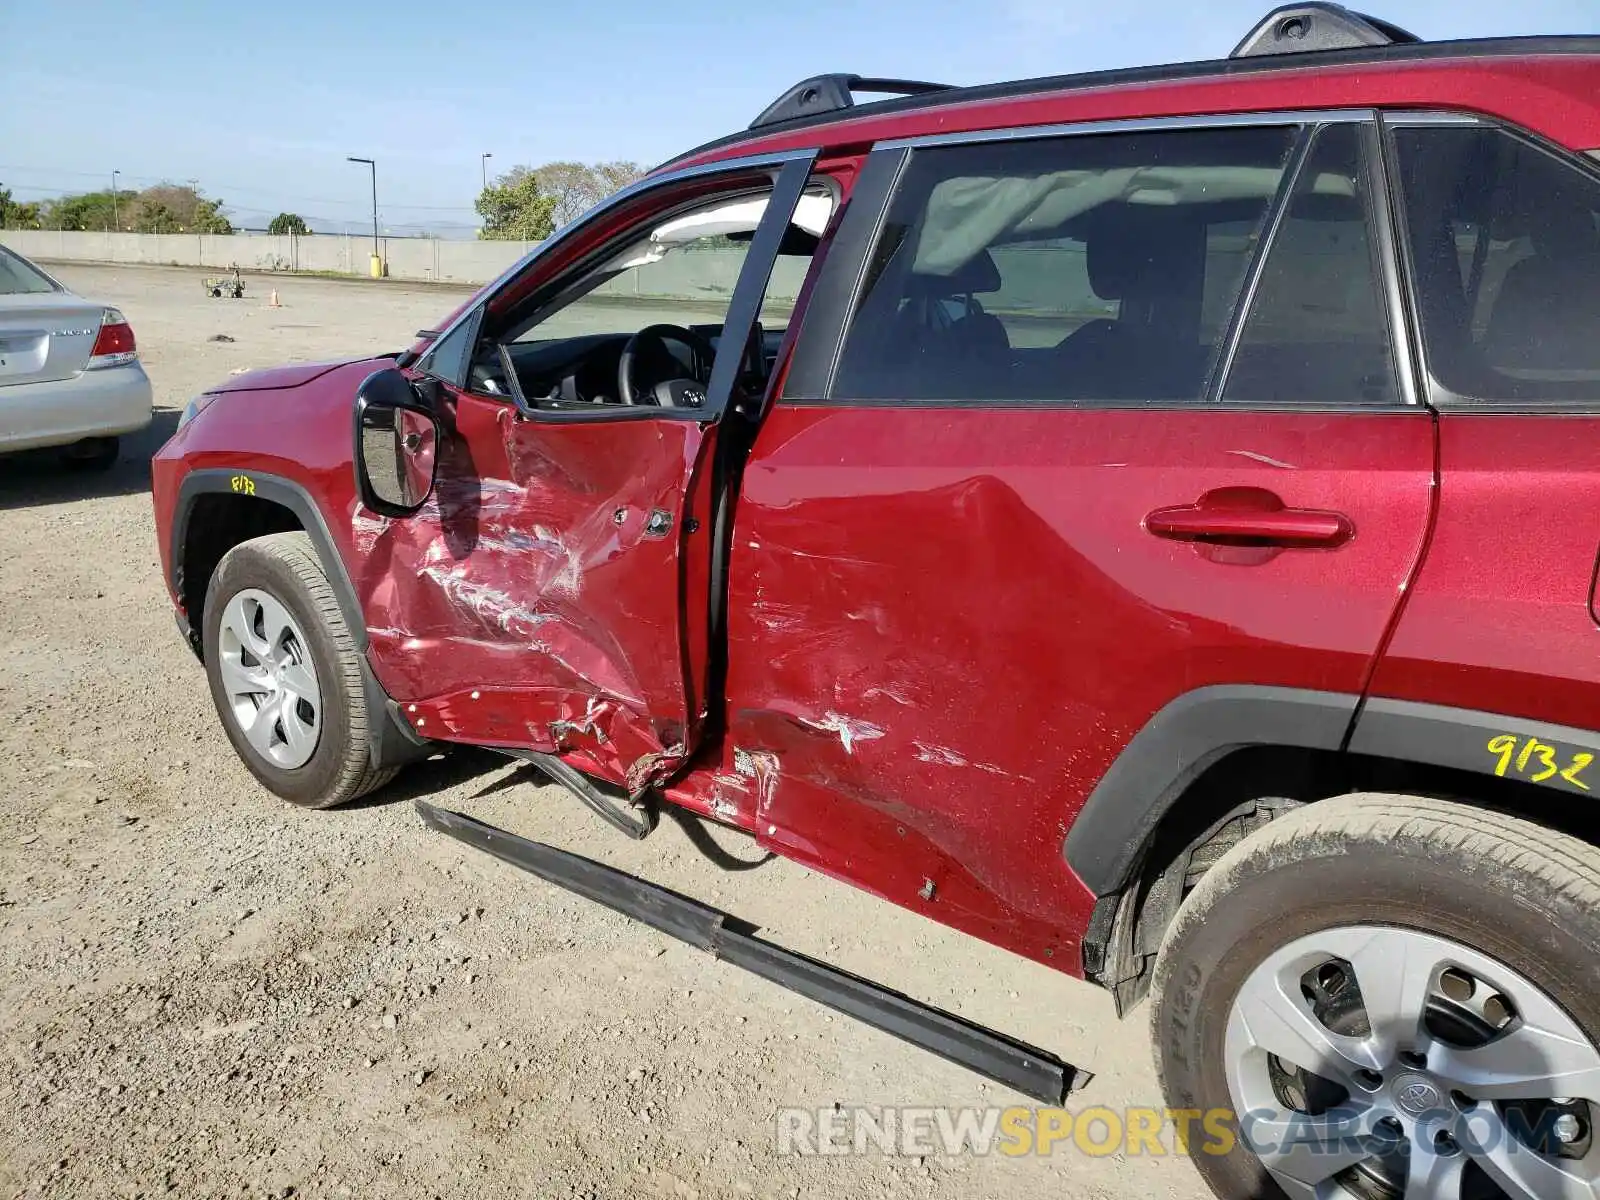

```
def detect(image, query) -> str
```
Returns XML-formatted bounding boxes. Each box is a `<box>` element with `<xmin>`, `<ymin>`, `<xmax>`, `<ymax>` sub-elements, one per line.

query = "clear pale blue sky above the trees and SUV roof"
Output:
<box><xmin>0</xmin><ymin>0</ymin><xmax>1600</xmax><ymax>227</ymax></box>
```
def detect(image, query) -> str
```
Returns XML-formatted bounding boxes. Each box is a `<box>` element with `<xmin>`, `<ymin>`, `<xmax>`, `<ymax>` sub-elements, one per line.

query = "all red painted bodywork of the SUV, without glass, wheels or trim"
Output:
<box><xmin>154</xmin><ymin>44</ymin><xmax>1600</xmax><ymax>973</ymax></box>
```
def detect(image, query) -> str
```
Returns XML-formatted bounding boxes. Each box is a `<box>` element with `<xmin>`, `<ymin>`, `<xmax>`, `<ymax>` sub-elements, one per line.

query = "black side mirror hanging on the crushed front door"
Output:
<box><xmin>355</xmin><ymin>366</ymin><xmax>438</xmax><ymax>517</ymax></box>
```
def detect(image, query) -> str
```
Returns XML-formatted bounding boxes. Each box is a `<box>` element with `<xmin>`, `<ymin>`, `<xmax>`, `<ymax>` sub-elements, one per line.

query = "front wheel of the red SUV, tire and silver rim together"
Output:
<box><xmin>203</xmin><ymin>533</ymin><xmax>397</xmax><ymax>808</ymax></box>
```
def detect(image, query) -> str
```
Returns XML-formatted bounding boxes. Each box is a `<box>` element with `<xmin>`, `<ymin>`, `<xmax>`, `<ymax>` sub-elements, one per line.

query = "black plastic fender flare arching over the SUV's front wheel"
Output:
<box><xmin>170</xmin><ymin>467</ymin><xmax>432</xmax><ymax>768</ymax></box>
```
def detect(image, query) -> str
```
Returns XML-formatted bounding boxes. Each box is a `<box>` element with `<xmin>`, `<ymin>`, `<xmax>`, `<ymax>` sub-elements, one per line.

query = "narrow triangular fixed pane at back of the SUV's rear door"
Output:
<box><xmin>1222</xmin><ymin>125</ymin><xmax>1400</xmax><ymax>406</ymax></box>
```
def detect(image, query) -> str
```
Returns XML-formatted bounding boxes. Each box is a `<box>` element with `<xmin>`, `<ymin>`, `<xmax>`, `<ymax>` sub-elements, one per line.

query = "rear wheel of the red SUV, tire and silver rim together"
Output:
<box><xmin>1150</xmin><ymin>795</ymin><xmax>1600</xmax><ymax>1200</ymax></box>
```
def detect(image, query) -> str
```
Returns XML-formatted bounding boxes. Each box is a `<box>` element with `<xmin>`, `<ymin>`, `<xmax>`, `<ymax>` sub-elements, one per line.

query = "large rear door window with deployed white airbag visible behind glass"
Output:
<box><xmin>832</xmin><ymin>126</ymin><xmax>1296</xmax><ymax>403</ymax></box>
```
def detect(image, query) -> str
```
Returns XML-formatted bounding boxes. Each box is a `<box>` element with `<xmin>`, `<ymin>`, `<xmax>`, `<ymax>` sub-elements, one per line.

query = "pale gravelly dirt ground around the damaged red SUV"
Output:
<box><xmin>0</xmin><ymin>267</ymin><xmax>1203</xmax><ymax>1200</ymax></box>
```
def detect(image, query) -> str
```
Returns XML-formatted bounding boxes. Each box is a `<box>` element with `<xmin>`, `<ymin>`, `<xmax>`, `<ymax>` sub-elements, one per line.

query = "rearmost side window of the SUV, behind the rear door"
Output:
<box><xmin>1394</xmin><ymin>126</ymin><xmax>1600</xmax><ymax>403</ymax></box>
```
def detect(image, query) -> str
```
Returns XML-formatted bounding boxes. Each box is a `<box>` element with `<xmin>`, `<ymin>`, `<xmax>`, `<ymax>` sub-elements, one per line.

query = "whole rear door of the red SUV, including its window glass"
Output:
<box><xmin>725</xmin><ymin>118</ymin><xmax>1435</xmax><ymax>968</ymax></box>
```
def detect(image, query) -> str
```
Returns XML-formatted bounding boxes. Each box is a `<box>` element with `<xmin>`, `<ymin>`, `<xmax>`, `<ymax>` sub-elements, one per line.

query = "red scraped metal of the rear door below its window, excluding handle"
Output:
<box><xmin>730</xmin><ymin>405</ymin><xmax>1434</xmax><ymax>957</ymax></box>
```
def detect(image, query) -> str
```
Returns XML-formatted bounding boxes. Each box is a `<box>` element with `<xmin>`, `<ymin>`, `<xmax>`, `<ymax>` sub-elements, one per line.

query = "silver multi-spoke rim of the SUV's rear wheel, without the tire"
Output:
<box><xmin>1226</xmin><ymin>926</ymin><xmax>1600</xmax><ymax>1200</ymax></box>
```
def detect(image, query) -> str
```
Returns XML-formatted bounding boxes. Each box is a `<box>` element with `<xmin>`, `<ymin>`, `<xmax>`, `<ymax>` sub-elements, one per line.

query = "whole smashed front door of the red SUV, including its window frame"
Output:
<box><xmin>358</xmin><ymin>154</ymin><xmax>811</xmax><ymax>794</ymax></box>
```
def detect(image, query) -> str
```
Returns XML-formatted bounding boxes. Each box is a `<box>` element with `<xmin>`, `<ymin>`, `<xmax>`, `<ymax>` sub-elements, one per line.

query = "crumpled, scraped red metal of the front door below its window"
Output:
<box><xmin>363</xmin><ymin>404</ymin><xmax>712</xmax><ymax>790</ymax></box>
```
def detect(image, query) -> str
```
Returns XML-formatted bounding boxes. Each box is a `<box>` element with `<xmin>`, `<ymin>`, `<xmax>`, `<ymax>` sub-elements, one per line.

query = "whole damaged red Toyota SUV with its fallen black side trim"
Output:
<box><xmin>155</xmin><ymin>5</ymin><xmax>1600</xmax><ymax>1200</ymax></box>
